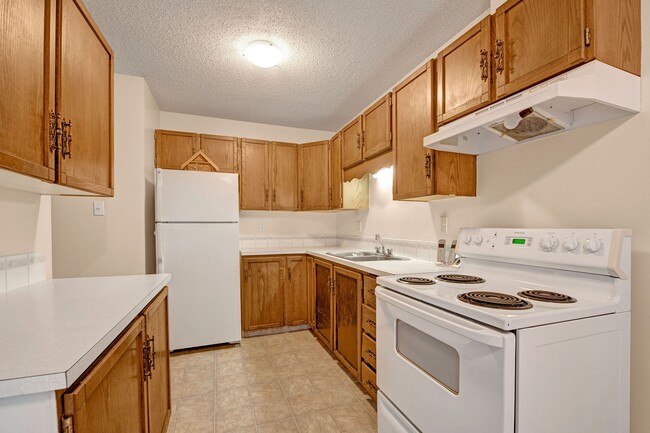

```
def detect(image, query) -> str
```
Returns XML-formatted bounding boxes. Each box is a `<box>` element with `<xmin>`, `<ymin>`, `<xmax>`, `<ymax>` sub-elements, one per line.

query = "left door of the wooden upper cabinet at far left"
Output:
<box><xmin>0</xmin><ymin>0</ymin><xmax>56</xmax><ymax>182</ymax></box>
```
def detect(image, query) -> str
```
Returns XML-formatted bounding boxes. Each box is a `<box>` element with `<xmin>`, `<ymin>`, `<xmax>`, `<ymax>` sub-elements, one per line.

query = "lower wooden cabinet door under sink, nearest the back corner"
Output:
<box><xmin>314</xmin><ymin>259</ymin><xmax>334</xmax><ymax>348</ymax></box>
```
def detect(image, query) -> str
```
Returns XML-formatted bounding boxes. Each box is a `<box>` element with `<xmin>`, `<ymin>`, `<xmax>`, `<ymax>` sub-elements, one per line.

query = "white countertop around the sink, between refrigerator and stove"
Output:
<box><xmin>241</xmin><ymin>247</ymin><xmax>444</xmax><ymax>276</ymax></box>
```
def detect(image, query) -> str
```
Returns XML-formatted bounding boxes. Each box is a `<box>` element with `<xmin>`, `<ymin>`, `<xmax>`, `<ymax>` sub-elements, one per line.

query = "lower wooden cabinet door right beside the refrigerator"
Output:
<box><xmin>242</xmin><ymin>257</ymin><xmax>285</xmax><ymax>331</ymax></box>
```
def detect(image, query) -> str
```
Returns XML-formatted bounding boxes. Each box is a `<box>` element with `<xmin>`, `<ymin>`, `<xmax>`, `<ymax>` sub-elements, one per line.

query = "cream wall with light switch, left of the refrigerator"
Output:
<box><xmin>52</xmin><ymin>75</ymin><xmax>158</xmax><ymax>277</ymax></box>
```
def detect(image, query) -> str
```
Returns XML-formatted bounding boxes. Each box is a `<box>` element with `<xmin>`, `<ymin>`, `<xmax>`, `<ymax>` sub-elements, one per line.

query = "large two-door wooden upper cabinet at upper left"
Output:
<box><xmin>0</xmin><ymin>0</ymin><xmax>113</xmax><ymax>196</ymax></box>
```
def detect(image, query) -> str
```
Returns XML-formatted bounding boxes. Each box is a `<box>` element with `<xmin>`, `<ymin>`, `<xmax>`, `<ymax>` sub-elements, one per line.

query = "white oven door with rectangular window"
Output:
<box><xmin>375</xmin><ymin>287</ymin><xmax>515</xmax><ymax>433</ymax></box>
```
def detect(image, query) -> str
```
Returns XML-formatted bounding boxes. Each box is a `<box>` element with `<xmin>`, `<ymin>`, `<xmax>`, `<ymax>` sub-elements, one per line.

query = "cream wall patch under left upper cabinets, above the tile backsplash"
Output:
<box><xmin>0</xmin><ymin>188</ymin><xmax>52</xmax><ymax>277</ymax></box>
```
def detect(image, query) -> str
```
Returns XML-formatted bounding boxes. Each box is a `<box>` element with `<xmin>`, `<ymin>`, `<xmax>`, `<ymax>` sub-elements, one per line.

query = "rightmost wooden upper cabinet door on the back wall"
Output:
<box><xmin>299</xmin><ymin>141</ymin><xmax>331</xmax><ymax>210</ymax></box>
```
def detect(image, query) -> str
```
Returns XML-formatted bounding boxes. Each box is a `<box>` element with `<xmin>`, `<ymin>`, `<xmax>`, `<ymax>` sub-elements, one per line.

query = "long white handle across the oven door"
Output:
<box><xmin>375</xmin><ymin>287</ymin><xmax>509</xmax><ymax>348</ymax></box>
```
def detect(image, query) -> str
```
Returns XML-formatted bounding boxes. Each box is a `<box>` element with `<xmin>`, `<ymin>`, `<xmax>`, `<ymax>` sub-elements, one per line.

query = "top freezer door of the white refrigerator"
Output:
<box><xmin>156</xmin><ymin>169</ymin><xmax>239</xmax><ymax>222</ymax></box>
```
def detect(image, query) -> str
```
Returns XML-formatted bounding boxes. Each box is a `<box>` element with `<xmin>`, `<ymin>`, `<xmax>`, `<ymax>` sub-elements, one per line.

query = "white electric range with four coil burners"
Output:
<box><xmin>376</xmin><ymin>228</ymin><xmax>631</xmax><ymax>433</ymax></box>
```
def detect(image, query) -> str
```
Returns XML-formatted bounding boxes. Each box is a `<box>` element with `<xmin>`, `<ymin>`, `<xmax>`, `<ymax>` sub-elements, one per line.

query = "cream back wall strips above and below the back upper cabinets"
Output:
<box><xmin>160</xmin><ymin>111</ymin><xmax>336</xmax><ymax>236</ymax></box>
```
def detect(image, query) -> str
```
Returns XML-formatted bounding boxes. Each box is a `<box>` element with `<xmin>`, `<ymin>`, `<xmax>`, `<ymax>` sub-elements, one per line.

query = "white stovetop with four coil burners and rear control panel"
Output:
<box><xmin>377</xmin><ymin>229</ymin><xmax>630</xmax><ymax>330</ymax></box>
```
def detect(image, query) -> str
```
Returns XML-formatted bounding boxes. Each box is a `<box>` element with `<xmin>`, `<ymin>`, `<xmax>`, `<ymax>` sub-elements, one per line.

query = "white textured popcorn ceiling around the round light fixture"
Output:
<box><xmin>85</xmin><ymin>0</ymin><xmax>490</xmax><ymax>131</ymax></box>
